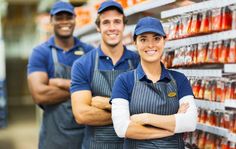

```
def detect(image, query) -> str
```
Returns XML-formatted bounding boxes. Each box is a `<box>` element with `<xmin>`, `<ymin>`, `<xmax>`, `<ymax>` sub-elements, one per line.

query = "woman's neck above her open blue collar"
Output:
<box><xmin>141</xmin><ymin>60</ymin><xmax>161</xmax><ymax>83</ymax></box>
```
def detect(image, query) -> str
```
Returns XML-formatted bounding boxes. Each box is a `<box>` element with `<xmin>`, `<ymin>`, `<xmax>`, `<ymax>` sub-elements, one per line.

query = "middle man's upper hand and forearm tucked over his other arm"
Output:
<box><xmin>91</xmin><ymin>96</ymin><xmax>111</xmax><ymax>110</ymax></box>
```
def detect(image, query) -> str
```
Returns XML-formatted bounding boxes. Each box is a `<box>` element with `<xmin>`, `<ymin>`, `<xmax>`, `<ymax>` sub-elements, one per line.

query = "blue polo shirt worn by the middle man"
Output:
<box><xmin>70</xmin><ymin>47</ymin><xmax>139</xmax><ymax>93</ymax></box>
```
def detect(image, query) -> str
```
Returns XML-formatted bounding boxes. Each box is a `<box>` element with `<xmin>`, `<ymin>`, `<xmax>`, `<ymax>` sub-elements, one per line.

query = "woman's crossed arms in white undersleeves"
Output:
<box><xmin>112</xmin><ymin>95</ymin><xmax>197</xmax><ymax>140</ymax></box>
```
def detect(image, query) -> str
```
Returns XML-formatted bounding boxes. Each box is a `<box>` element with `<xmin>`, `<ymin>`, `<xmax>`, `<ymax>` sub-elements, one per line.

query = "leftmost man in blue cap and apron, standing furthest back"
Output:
<box><xmin>28</xmin><ymin>1</ymin><xmax>93</xmax><ymax>149</ymax></box>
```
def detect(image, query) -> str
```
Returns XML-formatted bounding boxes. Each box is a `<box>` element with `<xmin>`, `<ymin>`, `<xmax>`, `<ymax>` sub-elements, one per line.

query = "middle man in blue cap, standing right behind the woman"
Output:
<box><xmin>71</xmin><ymin>1</ymin><xmax>139</xmax><ymax>149</ymax></box>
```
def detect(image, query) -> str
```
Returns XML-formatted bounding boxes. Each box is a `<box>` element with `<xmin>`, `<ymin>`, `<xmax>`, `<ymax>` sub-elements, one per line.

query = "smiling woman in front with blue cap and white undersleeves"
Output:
<box><xmin>111</xmin><ymin>17</ymin><xmax>197</xmax><ymax>149</ymax></box>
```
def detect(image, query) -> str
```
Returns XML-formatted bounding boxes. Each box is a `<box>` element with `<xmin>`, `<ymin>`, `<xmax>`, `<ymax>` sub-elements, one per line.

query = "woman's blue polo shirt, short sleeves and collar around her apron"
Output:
<box><xmin>111</xmin><ymin>64</ymin><xmax>193</xmax><ymax>102</ymax></box>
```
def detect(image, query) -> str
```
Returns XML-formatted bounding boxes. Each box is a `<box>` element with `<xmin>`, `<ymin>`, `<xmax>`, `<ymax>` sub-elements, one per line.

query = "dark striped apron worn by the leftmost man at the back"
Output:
<box><xmin>39</xmin><ymin>48</ymin><xmax>84</xmax><ymax>149</ymax></box>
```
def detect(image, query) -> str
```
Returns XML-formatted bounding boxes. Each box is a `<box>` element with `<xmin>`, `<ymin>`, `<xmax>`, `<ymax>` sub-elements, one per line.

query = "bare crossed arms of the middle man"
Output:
<box><xmin>71</xmin><ymin>90</ymin><xmax>112</xmax><ymax>126</ymax></box>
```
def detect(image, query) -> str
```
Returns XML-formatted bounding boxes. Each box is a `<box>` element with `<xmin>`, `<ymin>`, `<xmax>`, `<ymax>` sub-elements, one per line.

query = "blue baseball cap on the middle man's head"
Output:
<box><xmin>98</xmin><ymin>0</ymin><xmax>124</xmax><ymax>14</ymax></box>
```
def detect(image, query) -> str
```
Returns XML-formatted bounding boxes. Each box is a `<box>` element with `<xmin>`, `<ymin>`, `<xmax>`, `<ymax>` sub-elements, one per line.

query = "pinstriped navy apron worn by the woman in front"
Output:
<box><xmin>124</xmin><ymin>70</ymin><xmax>184</xmax><ymax>149</ymax></box>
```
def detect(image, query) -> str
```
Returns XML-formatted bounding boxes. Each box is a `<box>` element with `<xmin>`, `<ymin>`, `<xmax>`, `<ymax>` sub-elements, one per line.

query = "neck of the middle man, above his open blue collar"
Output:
<box><xmin>101</xmin><ymin>42</ymin><xmax>124</xmax><ymax>65</ymax></box>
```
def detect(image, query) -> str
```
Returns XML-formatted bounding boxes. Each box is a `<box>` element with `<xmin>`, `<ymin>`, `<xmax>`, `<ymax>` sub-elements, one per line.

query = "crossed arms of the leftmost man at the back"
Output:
<box><xmin>27</xmin><ymin>72</ymin><xmax>70</xmax><ymax>105</ymax></box>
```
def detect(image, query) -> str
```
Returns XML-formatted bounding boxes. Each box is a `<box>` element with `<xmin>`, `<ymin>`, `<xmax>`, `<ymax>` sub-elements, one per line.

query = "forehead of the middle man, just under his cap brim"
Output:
<box><xmin>100</xmin><ymin>9</ymin><xmax>123</xmax><ymax>21</ymax></box>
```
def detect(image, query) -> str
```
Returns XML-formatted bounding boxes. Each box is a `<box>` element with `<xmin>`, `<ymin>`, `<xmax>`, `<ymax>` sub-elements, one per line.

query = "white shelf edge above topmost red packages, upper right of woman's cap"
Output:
<box><xmin>161</xmin><ymin>0</ymin><xmax>236</xmax><ymax>18</ymax></box>
